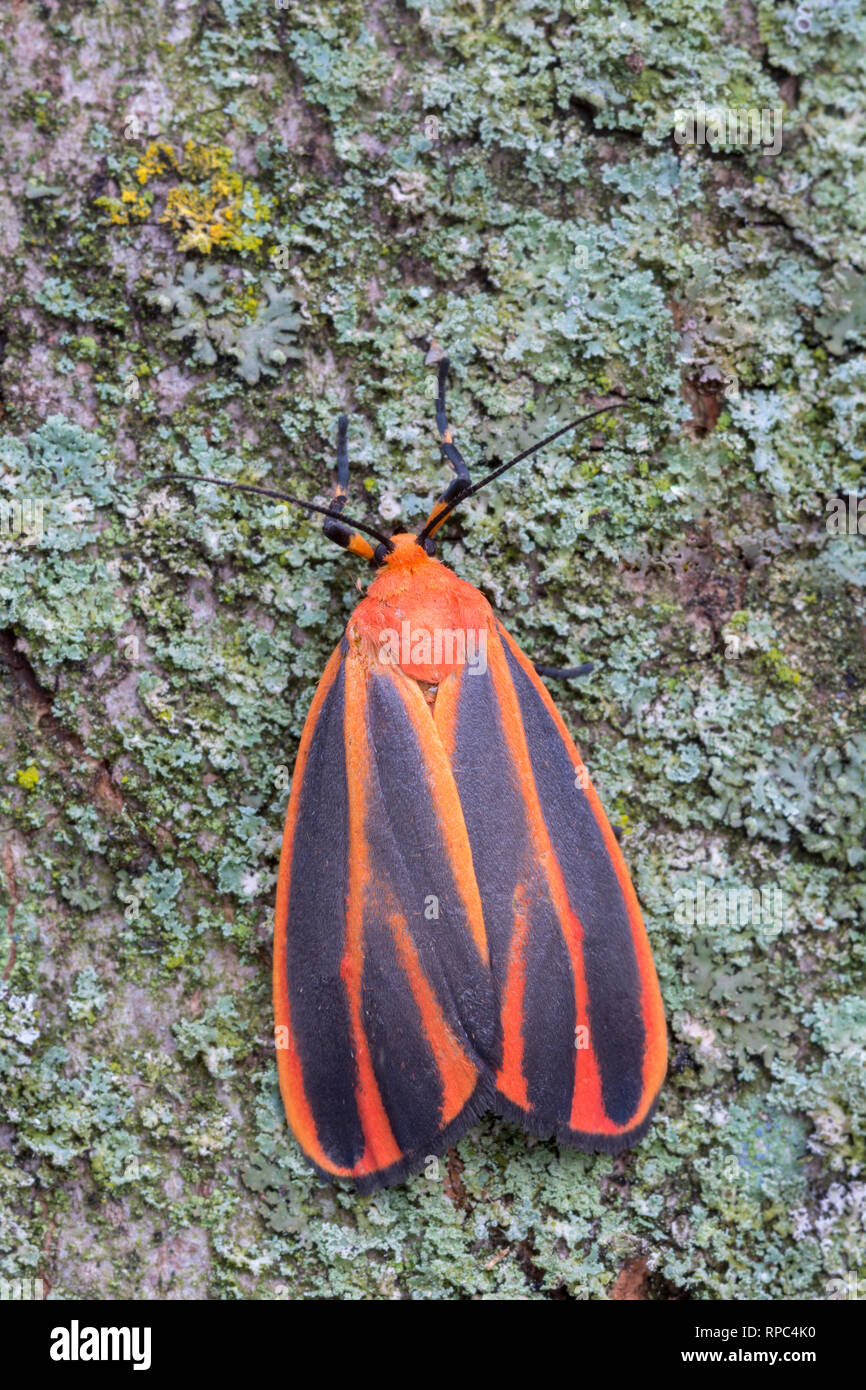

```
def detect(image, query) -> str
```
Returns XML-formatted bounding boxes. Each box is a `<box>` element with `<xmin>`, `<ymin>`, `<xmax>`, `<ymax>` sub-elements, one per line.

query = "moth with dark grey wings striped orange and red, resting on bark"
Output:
<box><xmin>161</xmin><ymin>357</ymin><xmax>666</xmax><ymax>1190</ymax></box>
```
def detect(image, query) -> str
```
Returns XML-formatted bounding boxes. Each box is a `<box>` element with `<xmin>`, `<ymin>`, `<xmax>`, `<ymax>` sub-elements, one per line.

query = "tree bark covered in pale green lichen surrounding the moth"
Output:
<box><xmin>0</xmin><ymin>0</ymin><xmax>866</xmax><ymax>1298</ymax></box>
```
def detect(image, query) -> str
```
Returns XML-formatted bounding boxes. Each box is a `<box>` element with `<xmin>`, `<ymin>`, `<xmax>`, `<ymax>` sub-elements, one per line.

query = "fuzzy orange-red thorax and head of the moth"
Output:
<box><xmin>346</xmin><ymin>535</ymin><xmax>492</xmax><ymax>685</ymax></box>
